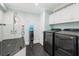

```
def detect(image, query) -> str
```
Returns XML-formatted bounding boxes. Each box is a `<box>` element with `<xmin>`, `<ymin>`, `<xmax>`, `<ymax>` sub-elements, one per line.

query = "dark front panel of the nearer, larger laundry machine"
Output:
<box><xmin>55</xmin><ymin>34</ymin><xmax>76</xmax><ymax>56</ymax></box>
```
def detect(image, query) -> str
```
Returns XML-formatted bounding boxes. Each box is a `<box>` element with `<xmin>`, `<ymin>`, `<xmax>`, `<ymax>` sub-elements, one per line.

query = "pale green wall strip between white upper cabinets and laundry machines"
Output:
<box><xmin>50</xmin><ymin>22</ymin><xmax>79</xmax><ymax>29</ymax></box>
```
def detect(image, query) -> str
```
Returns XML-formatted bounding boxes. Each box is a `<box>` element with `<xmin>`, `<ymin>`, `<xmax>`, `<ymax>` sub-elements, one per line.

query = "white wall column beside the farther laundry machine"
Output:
<box><xmin>39</xmin><ymin>9</ymin><xmax>50</xmax><ymax>45</ymax></box>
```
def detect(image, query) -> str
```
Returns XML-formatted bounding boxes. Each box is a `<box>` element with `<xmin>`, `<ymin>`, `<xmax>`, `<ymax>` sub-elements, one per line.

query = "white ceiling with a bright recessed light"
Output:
<box><xmin>5</xmin><ymin>3</ymin><xmax>69</xmax><ymax>14</ymax></box>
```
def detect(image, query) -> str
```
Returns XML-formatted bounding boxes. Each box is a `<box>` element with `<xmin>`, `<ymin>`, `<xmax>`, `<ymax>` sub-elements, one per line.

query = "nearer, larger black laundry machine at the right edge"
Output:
<box><xmin>54</xmin><ymin>29</ymin><xmax>79</xmax><ymax>56</ymax></box>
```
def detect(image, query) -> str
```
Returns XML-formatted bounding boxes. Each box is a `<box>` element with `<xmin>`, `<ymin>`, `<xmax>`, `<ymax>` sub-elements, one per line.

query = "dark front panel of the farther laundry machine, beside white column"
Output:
<box><xmin>44</xmin><ymin>32</ymin><xmax>53</xmax><ymax>55</ymax></box>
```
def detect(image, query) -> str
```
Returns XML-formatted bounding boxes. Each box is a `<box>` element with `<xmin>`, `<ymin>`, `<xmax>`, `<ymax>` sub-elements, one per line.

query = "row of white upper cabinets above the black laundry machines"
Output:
<box><xmin>49</xmin><ymin>4</ymin><xmax>79</xmax><ymax>24</ymax></box>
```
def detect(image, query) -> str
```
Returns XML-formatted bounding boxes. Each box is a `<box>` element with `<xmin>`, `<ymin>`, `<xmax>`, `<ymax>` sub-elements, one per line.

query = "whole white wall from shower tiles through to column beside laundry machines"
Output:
<box><xmin>0</xmin><ymin>8</ymin><xmax>49</xmax><ymax>45</ymax></box>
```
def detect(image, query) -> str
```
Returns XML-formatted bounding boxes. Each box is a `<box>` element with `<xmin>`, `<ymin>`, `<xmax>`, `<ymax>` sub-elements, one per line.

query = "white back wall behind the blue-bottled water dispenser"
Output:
<box><xmin>18</xmin><ymin>12</ymin><xmax>41</xmax><ymax>45</ymax></box>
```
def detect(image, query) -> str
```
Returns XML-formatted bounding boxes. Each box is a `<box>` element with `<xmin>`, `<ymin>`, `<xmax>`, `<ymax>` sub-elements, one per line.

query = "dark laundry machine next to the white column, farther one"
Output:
<box><xmin>44</xmin><ymin>29</ymin><xmax>61</xmax><ymax>56</ymax></box>
